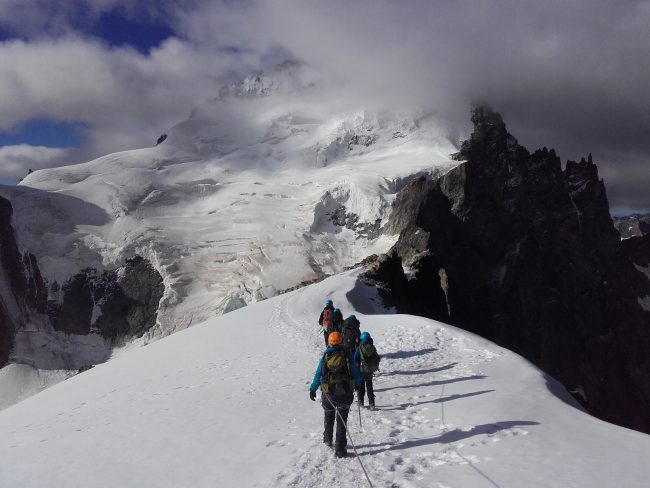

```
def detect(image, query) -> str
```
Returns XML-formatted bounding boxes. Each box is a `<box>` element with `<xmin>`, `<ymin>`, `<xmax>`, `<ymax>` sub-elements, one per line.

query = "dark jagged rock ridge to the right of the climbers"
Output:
<box><xmin>367</xmin><ymin>107</ymin><xmax>650</xmax><ymax>432</ymax></box>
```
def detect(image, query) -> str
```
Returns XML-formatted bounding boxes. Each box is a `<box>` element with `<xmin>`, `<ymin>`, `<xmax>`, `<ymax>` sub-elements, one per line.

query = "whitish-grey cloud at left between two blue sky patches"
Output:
<box><xmin>0</xmin><ymin>36</ymin><xmax>256</xmax><ymax>155</ymax></box>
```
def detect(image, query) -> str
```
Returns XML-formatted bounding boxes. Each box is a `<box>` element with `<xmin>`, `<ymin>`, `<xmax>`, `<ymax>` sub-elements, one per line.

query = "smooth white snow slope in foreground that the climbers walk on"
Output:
<box><xmin>0</xmin><ymin>271</ymin><xmax>650</xmax><ymax>488</ymax></box>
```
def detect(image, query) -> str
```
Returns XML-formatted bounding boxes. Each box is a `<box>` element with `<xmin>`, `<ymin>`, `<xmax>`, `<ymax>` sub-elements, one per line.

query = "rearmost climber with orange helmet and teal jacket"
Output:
<box><xmin>309</xmin><ymin>331</ymin><xmax>362</xmax><ymax>457</ymax></box>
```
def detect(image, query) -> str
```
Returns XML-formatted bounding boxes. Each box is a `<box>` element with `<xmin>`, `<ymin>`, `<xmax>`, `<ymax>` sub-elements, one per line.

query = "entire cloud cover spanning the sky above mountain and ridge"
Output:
<box><xmin>0</xmin><ymin>0</ymin><xmax>650</xmax><ymax>212</ymax></box>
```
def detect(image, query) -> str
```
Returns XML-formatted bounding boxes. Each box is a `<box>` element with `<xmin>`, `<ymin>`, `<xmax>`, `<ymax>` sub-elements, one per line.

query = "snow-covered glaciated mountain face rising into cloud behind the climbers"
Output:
<box><xmin>5</xmin><ymin>79</ymin><xmax>457</xmax><ymax>346</ymax></box>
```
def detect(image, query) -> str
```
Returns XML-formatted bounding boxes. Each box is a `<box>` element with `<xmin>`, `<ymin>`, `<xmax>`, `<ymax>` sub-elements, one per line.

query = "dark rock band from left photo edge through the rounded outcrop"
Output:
<box><xmin>0</xmin><ymin>197</ymin><xmax>164</xmax><ymax>367</ymax></box>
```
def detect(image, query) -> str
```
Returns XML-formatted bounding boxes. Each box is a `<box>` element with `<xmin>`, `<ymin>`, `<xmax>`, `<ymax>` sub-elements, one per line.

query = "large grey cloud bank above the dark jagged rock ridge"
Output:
<box><xmin>180</xmin><ymin>0</ymin><xmax>650</xmax><ymax>208</ymax></box>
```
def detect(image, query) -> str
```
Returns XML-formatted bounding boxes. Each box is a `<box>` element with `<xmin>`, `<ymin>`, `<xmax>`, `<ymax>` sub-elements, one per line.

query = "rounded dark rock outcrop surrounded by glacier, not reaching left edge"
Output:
<box><xmin>48</xmin><ymin>256</ymin><xmax>164</xmax><ymax>341</ymax></box>
